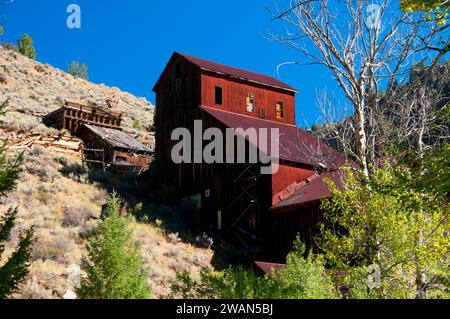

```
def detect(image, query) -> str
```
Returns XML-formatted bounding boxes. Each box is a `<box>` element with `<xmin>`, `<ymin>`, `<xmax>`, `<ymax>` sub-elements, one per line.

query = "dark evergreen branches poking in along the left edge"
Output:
<box><xmin>0</xmin><ymin>118</ymin><xmax>33</xmax><ymax>299</ymax></box>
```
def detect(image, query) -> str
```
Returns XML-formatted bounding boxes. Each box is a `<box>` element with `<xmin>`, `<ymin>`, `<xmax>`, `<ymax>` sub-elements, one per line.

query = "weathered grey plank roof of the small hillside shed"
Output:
<box><xmin>84</xmin><ymin>124</ymin><xmax>153</xmax><ymax>153</ymax></box>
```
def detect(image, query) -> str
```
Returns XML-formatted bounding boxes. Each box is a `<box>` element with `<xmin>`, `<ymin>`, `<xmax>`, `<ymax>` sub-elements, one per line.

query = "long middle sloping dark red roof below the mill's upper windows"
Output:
<box><xmin>201</xmin><ymin>106</ymin><xmax>347</xmax><ymax>170</ymax></box>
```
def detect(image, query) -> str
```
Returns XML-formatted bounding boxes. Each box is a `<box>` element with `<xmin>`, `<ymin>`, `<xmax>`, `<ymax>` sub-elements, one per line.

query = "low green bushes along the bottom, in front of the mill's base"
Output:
<box><xmin>172</xmin><ymin>240</ymin><xmax>339</xmax><ymax>299</ymax></box>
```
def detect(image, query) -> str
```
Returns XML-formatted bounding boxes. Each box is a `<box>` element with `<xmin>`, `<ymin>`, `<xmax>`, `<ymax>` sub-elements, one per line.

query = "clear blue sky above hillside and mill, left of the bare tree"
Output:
<box><xmin>0</xmin><ymin>0</ymin><xmax>340</xmax><ymax>126</ymax></box>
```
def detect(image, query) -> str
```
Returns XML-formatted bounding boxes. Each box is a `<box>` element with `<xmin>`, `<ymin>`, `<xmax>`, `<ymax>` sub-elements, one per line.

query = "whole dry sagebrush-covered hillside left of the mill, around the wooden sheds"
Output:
<box><xmin>0</xmin><ymin>43</ymin><xmax>218</xmax><ymax>298</ymax></box>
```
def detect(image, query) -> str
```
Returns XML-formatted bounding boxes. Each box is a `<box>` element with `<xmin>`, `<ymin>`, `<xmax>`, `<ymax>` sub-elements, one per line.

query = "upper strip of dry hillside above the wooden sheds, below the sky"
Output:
<box><xmin>0</xmin><ymin>46</ymin><xmax>154</xmax><ymax>144</ymax></box>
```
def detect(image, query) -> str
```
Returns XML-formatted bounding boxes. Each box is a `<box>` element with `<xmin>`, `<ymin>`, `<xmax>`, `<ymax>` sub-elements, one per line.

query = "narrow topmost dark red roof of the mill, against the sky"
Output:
<box><xmin>175</xmin><ymin>52</ymin><xmax>297</xmax><ymax>92</ymax></box>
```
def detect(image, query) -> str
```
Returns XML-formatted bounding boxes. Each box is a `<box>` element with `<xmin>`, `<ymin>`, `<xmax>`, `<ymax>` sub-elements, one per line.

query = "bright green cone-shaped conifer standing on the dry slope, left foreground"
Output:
<box><xmin>77</xmin><ymin>193</ymin><xmax>150</xmax><ymax>299</ymax></box>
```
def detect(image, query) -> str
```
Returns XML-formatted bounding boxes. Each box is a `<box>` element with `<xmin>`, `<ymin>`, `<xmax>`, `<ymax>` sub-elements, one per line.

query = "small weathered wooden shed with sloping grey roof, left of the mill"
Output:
<box><xmin>80</xmin><ymin>124</ymin><xmax>153</xmax><ymax>176</ymax></box>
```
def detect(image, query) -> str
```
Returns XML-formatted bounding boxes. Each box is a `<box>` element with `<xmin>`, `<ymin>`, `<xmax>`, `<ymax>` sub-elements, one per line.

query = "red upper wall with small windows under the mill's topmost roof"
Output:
<box><xmin>201</xmin><ymin>71</ymin><xmax>295</xmax><ymax>125</ymax></box>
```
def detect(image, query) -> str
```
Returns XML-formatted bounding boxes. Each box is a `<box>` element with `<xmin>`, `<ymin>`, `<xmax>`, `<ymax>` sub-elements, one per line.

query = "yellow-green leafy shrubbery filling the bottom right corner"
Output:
<box><xmin>320</xmin><ymin>162</ymin><xmax>450</xmax><ymax>299</ymax></box>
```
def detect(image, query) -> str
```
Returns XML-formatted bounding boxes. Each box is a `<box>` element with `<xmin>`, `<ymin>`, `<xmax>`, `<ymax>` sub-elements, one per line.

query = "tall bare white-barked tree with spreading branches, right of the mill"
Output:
<box><xmin>272</xmin><ymin>0</ymin><xmax>446</xmax><ymax>178</ymax></box>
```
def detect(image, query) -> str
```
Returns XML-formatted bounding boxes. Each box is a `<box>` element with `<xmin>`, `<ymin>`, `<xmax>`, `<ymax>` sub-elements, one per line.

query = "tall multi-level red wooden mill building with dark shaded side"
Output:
<box><xmin>153</xmin><ymin>53</ymin><xmax>346</xmax><ymax>260</ymax></box>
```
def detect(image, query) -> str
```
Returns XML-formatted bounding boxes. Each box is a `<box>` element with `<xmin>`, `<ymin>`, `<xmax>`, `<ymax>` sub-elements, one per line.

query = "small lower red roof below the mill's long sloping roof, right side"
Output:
<box><xmin>271</xmin><ymin>171</ymin><xmax>343</xmax><ymax>210</ymax></box>
